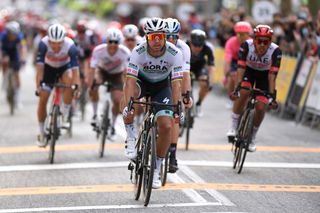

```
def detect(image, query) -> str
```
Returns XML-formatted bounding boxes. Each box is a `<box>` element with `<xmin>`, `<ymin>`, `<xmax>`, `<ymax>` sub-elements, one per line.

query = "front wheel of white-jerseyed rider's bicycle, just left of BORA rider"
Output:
<box><xmin>99</xmin><ymin>101</ymin><xmax>110</xmax><ymax>158</ymax></box>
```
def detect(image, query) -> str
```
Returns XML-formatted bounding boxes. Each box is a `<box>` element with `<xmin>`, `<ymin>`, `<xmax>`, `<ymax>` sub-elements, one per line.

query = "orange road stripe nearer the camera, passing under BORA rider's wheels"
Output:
<box><xmin>0</xmin><ymin>183</ymin><xmax>320</xmax><ymax>196</ymax></box>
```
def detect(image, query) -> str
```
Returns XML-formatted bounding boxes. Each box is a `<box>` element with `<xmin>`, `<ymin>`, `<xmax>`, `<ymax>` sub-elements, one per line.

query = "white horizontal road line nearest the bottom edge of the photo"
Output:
<box><xmin>0</xmin><ymin>203</ymin><xmax>228</xmax><ymax>213</ymax></box>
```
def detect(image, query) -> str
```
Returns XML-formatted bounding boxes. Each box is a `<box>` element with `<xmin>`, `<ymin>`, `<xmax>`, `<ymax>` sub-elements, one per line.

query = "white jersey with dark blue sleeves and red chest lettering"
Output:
<box><xmin>37</xmin><ymin>36</ymin><xmax>78</xmax><ymax>68</ymax></box>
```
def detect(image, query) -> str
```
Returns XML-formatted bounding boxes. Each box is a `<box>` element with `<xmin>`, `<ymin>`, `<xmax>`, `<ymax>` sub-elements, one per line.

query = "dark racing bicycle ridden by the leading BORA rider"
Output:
<box><xmin>128</xmin><ymin>97</ymin><xmax>181</xmax><ymax>206</ymax></box>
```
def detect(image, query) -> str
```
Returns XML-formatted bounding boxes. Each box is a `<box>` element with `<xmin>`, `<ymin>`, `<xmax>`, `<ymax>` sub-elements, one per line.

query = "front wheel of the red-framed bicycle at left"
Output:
<box><xmin>49</xmin><ymin>106</ymin><xmax>60</xmax><ymax>164</ymax></box>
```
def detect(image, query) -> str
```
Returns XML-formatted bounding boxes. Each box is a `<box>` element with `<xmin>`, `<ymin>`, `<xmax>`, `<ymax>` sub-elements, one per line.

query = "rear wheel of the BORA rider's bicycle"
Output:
<box><xmin>133</xmin><ymin>130</ymin><xmax>146</xmax><ymax>200</ymax></box>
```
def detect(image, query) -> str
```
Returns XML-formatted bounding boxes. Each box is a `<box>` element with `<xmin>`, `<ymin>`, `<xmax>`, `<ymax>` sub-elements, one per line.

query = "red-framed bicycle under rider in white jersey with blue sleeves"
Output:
<box><xmin>36</xmin><ymin>83</ymin><xmax>78</xmax><ymax>164</ymax></box>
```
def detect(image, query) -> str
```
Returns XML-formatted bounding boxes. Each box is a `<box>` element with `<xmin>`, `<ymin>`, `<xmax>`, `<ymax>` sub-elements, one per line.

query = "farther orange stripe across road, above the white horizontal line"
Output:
<box><xmin>0</xmin><ymin>142</ymin><xmax>320</xmax><ymax>154</ymax></box>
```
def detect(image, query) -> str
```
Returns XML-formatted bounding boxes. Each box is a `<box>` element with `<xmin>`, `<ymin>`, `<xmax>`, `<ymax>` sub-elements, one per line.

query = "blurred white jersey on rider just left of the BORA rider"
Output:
<box><xmin>90</xmin><ymin>44</ymin><xmax>130</xmax><ymax>74</ymax></box>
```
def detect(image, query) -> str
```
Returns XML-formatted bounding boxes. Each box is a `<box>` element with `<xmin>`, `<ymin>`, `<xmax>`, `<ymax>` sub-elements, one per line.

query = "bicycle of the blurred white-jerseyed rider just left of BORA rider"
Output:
<box><xmin>92</xmin><ymin>82</ymin><xmax>111</xmax><ymax>158</ymax></box>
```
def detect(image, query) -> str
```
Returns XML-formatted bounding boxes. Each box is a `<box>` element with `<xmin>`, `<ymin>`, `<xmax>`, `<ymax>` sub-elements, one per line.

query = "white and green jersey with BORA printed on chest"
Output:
<box><xmin>127</xmin><ymin>42</ymin><xmax>183</xmax><ymax>83</ymax></box>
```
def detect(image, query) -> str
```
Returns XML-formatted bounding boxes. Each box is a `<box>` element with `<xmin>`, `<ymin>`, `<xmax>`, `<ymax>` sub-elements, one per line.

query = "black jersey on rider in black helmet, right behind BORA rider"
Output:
<box><xmin>187</xmin><ymin>41</ymin><xmax>214</xmax><ymax>75</ymax></box>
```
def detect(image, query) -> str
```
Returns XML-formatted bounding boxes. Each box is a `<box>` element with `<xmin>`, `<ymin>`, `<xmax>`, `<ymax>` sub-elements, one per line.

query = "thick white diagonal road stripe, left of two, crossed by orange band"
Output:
<box><xmin>180</xmin><ymin>166</ymin><xmax>235</xmax><ymax>206</ymax></box>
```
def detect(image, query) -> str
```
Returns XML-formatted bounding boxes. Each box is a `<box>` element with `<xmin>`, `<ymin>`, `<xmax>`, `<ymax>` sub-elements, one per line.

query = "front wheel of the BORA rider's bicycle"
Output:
<box><xmin>143</xmin><ymin>127</ymin><xmax>156</xmax><ymax>206</ymax></box>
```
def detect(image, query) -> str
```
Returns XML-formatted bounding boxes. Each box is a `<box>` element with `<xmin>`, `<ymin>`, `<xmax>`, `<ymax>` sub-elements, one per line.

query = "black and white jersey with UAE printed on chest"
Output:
<box><xmin>238</xmin><ymin>39</ymin><xmax>282</xmax><ymax>72</ymax></box>
